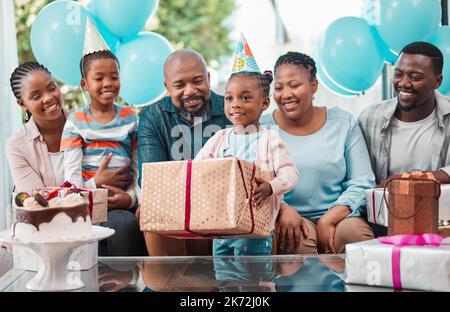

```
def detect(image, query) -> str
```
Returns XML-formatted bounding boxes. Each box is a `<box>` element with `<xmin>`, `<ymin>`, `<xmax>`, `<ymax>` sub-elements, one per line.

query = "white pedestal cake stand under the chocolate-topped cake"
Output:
<box><xmin>0</xmin><ymin>226</ymin><xmax>114</xmax><ymax>291</ymax></box>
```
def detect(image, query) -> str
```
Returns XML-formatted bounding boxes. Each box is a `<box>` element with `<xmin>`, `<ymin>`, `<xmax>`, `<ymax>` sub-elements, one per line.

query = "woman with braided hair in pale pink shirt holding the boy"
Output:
<box><xmin>7</xmin><ymin>62</ymin><xmax>146</xmax><ymax>256</ymax></box>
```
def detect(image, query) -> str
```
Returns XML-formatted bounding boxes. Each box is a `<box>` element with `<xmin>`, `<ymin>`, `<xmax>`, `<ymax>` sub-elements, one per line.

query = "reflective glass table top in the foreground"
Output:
<box><xmin>0</xmin><ymin>251</ymin><xmax>392</xmax><ymax>292</ymax></box>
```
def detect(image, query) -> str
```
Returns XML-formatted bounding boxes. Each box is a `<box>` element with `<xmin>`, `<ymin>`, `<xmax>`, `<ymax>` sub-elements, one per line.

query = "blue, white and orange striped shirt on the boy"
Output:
<box><xmin>61</xmin><ymin>104</ymin><xmax>138</xmax><ymax>205</ymax></box>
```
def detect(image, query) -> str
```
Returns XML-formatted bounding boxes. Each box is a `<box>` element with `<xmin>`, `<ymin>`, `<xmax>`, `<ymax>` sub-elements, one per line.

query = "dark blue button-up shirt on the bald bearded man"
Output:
<box><xmin>138</xmin><ymin>91</ymin><xmax>231</xmax><ymax>183</ymax></box>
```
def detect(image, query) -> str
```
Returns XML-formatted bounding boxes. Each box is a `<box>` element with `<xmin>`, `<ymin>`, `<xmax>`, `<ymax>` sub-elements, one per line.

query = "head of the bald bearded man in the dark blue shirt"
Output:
<box><xmin>164</xmin><ymin>49</ymin><xmax>211</xmax><ymax>116</ymax></box>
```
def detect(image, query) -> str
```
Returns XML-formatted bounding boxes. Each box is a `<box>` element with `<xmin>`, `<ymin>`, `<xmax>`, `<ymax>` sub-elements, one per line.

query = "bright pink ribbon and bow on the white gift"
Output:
<box><xmin>378</xmin><ymin>233</ymin><xmax>450</xmax><ymax>289</ymax></box>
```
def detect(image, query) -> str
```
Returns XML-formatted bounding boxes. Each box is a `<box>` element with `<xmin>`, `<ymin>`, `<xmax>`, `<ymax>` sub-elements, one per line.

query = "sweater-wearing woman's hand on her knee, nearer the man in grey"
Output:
<box><xmin>317</xmin><ymin>206</ymin><xmax>351</xmax><ymax>253</ymax></box>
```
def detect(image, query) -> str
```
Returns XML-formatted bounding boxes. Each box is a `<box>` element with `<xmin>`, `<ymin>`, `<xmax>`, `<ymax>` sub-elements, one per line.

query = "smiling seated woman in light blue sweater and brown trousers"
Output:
<box><xmin>262</xmin><ymin>52</ymin><xmax>375</xmax><ymax>254</ymax></box>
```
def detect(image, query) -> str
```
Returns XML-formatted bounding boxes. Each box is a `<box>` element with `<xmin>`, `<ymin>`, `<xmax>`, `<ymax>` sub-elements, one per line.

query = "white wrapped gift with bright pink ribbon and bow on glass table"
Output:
<box><xmin>345</xmin><ymin>234</ymin><xmax>450</xmax><ymax>291</ymax></box>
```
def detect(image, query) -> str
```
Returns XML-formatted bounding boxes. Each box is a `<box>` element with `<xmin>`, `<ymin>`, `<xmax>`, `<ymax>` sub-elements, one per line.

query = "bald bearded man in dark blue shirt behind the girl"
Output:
<box><xmin>138</xmin><ymin>50</ymin><xmax>230</xmax><ymax>256</ymax></box>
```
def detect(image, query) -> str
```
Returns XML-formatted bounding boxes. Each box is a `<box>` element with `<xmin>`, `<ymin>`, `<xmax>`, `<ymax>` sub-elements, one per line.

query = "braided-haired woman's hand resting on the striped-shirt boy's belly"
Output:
<box><xmin>94</xmin><ymin>154</ymin><xmax>133</xmax><ymax>190</ymax></box>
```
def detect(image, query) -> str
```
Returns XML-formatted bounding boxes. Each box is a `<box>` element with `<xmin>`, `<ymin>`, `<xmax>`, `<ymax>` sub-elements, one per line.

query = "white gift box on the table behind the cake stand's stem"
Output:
<box><xmin>13</xmin><ymin>242</ymin><xmax>98</xmax><ymax>271</ymax></box>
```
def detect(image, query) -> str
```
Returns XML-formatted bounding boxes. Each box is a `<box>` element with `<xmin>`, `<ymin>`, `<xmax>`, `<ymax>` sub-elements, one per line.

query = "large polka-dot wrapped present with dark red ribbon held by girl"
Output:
<box><xmin>140</xmin><ymin>158</ymin><xmax>273</xmax><ymax>238</ymax></box>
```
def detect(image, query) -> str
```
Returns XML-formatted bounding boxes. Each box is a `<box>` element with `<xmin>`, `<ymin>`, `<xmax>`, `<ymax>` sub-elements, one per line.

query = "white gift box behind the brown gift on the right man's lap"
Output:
<box><xmin>366</xmin><ymin>184</ymin><xmax>450</xmax><ymax>226</ymax></box>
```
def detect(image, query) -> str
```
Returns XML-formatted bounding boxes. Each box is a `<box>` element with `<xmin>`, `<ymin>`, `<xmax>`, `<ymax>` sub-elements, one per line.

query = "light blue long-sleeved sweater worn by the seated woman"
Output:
<box><xmin>261</xmin><ymin>107</ymin><xmax>375</xmax><ymax>222</ymax></box>
